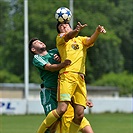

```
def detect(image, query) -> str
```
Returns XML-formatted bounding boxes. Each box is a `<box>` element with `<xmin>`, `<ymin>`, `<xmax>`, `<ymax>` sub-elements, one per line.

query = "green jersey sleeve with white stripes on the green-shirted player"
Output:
<box><xmin>33</xmin><ymin>55</ymin><xmax>47</xmax><ymax>69</ymax></box>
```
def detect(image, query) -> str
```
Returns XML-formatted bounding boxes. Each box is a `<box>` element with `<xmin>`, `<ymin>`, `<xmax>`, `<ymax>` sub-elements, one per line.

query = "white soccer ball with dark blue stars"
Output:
<box><xmin>55</xmin><ymin>7</ymin><xmax>72</xmax><ymax>23</ymax></box>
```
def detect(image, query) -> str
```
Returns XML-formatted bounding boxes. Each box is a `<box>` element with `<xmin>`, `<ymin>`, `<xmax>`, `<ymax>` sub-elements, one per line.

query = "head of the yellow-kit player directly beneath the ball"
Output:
<box><xmin>56</xmin><ymin>22</ymin><xmax>72</xmax><ymax>33</ymax></box>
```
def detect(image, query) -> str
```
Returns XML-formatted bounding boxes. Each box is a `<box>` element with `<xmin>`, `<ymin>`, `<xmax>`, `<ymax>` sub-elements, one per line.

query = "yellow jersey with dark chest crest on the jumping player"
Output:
<box><xmin>56</xmin><ymin>33</ymin><xmax>93</xmax><ymax>74</ymax></box>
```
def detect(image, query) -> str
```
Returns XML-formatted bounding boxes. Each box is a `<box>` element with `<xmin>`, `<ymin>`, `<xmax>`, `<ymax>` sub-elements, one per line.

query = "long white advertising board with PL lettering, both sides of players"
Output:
<box><xmin>0</xmin><ymin>97</ymin><xmax>133</xmax><ymax>114</ymax></box>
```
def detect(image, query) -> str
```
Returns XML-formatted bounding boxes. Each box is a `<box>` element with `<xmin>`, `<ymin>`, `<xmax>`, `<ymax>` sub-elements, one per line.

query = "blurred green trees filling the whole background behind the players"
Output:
<box><xmin>0</xmin><ymin>0</ymin><xmax>133</xmax><ymax>89</ymax></box>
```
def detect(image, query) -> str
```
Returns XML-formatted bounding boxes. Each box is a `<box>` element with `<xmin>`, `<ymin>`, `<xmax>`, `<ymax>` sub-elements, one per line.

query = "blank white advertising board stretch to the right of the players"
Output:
<box><xmin>91</xmin><ymin>98</ymin><xmax>133</xmax><ymax>113</ymax></box>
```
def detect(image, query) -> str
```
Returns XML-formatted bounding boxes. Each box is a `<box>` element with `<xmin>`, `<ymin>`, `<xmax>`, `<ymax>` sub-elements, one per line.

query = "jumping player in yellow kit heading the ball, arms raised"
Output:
<box><xmin>37</xmin><ymin>22</ymin><xmax>106</xmax><ymax>133</ymax></box>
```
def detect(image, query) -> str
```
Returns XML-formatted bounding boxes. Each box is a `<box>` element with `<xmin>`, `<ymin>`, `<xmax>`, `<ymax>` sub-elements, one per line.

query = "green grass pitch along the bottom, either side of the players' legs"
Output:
<box><xmin>0</xmin><ymin>113</ymin><xmax>133</xmax><ymax>133</ymax></box>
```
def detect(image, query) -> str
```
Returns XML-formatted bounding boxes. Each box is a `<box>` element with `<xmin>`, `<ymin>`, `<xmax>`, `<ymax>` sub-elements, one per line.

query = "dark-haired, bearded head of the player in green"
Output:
<box><xmin>29</xmin><ymin>38</ymin><xmax>46</xmax><ymax>54</ymax></box>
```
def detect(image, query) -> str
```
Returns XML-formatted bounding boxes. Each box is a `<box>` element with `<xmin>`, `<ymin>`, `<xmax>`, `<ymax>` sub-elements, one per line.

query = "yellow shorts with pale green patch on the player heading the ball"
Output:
<box><xmin>57</xmin><ymin>72</ymin><xmax>87</xmax><ymax>107</ymax></box>
